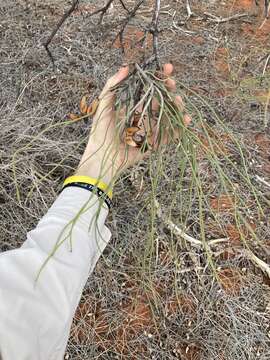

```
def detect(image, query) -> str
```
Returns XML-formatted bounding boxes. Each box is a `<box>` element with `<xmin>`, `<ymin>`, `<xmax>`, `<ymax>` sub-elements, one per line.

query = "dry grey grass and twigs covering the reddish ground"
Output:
<box><xmin>0</xmin><ymin>0</ymin><xmax>270</xmax><ymax>360</ymax></box>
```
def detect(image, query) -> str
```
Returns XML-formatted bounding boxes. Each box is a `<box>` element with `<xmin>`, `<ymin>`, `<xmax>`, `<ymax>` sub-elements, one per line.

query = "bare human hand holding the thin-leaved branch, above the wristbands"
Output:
<box><xmin>76</xmin><ymin>64</ymin><xmax>191</xmax><ymax>184</ymax></box>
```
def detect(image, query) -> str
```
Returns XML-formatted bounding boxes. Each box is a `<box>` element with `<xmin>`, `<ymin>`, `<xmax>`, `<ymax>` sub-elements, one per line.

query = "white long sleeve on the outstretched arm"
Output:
<box><xmin>0</xmin><ymin>187</ymin><xmax>111</xmax><ymax>360</ymax></box>
